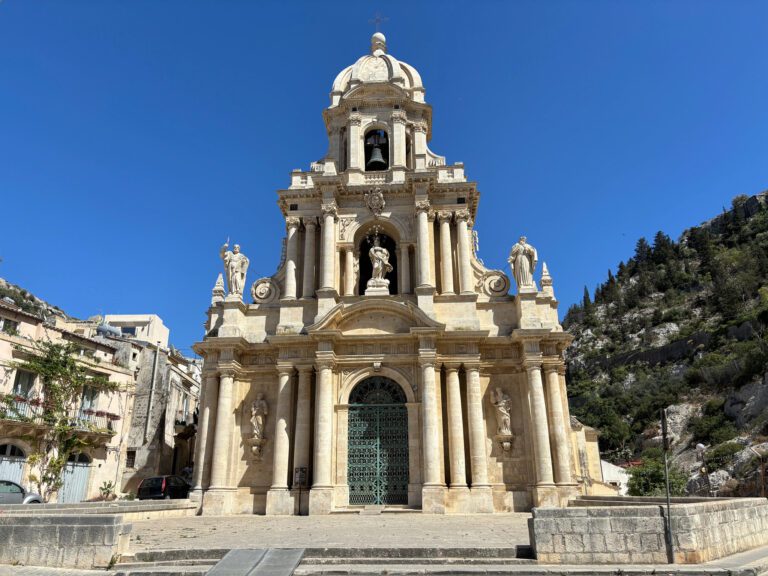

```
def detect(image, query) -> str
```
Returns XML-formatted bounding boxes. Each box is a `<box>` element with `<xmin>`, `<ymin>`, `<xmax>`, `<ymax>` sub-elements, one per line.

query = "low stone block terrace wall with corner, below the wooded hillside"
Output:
<box><xmin>528</xmin><ymin>498</ymin><xmax>768</xmax><ymax>564</ymax></box>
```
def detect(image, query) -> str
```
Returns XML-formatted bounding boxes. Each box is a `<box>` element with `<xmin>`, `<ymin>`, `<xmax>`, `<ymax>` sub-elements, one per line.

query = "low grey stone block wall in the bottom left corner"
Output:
<box><xmin>0</xmin><ymin>514</ymin><xmax>131</xmax><ymax>568</ymax></box>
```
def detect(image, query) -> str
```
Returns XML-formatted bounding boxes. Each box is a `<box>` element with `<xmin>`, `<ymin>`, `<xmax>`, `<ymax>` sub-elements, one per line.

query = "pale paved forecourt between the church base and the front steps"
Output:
<box><xmin>131</xmin><ymin>513</ymin><xmax>530</xmax><ymax>552</ymax></box>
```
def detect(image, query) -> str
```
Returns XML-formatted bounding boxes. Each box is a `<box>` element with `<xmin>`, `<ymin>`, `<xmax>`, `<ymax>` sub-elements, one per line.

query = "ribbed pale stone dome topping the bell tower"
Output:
<box><xmin>331</xmin><ymin>32</ymin><xmax>424</xmax><ymax>107</ymax></box>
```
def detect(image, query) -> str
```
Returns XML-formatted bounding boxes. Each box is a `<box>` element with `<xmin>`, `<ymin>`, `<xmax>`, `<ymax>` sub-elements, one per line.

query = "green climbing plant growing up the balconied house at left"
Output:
<box><xmin>12</xmin><ymin>340</ymin><xmax>117</xmax><ymax>502</ymax></box>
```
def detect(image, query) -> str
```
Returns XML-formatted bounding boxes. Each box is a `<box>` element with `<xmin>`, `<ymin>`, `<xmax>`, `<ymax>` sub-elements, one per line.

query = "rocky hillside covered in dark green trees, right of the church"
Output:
<box><xmin>564</xmin><ymin>191</ymin><xmax>768</xmax><ymax>492</ymax></box>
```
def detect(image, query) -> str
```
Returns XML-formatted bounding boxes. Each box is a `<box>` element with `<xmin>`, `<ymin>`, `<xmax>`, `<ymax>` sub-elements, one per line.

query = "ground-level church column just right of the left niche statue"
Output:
<box><xmin>266</xmin><ymin>366</ymin><xmax>294</xmax><ymax>515</ymax></box>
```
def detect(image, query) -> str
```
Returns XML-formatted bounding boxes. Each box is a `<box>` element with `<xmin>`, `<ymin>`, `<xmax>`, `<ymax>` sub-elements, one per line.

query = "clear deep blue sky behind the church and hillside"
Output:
<box><xmin>0</xmin><ymin>0</ymin><xmax>768</xmax><ymax>352</ymax></box>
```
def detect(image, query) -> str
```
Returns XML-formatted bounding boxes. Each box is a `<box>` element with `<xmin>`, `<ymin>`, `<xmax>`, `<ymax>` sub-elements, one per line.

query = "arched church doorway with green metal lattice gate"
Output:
<box><xmin>347</xmin><ymin>376</ymin><xmax>408</xmax><ymax>506</ymax></box>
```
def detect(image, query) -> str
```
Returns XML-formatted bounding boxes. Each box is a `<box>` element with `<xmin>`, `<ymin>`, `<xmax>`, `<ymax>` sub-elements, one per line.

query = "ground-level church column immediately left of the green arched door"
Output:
<box><xmin>309</xmin><ymin>361</ymin><xmax>333</xmax><ymax>515</ymax></box>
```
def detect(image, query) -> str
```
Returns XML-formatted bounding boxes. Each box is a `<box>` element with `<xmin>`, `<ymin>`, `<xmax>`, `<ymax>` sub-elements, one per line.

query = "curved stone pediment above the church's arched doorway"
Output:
<box><xmin>307</xmin><ymin>298</ymin><xmax>445</xmax><ymax>336</ymax></box>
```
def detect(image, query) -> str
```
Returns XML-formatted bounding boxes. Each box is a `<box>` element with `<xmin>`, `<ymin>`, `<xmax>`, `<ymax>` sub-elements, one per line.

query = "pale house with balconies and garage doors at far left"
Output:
<box><xmin>0</xmin><ymin>299</ymin><xmax>134</xmax><ymax>503</ymax></box>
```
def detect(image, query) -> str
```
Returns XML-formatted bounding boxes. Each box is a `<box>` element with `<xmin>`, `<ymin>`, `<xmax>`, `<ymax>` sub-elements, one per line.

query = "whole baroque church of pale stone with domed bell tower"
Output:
<box><xmin>192</xmin><ymin>32</ymin><xmax>615</xmax><ymax>515</ymax></box>
